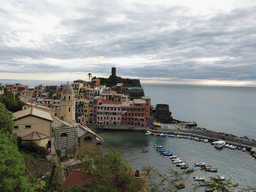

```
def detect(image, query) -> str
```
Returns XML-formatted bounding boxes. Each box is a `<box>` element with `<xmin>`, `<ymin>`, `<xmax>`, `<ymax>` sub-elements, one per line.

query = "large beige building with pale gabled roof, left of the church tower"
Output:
<box><xmin>13</xmin><ymin>107</ymin><xmax>53</xmax><ymax>147</ymax></box>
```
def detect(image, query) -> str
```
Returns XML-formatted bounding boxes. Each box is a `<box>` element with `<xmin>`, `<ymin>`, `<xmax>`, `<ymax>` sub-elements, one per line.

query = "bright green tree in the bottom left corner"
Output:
<box><xmin>0</xmin><ymin>133</ymin><xmax>35</xmax><ymax>191</ymax></box>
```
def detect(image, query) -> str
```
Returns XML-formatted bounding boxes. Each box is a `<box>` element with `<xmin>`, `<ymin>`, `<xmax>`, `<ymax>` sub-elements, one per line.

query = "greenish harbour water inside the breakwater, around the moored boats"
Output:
<box><xmin>99</xmin><ymin>131</ymin><xmax>256</xmax><ymax>192</ymax></box>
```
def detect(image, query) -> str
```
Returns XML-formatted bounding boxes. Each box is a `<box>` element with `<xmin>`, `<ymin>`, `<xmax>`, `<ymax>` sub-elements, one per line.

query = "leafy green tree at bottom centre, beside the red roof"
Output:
<box><xmin>68</xmin><ymin>148</ymin><xmax>145</xmax><ymax>192</ymax></box>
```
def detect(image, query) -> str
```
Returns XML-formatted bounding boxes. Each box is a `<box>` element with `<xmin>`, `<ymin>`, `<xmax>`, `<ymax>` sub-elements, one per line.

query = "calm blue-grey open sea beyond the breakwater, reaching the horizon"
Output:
<box><xmin>143</xmin><ymin>84</ymin><xmax>256</xmax><ymax>139</ymax></box>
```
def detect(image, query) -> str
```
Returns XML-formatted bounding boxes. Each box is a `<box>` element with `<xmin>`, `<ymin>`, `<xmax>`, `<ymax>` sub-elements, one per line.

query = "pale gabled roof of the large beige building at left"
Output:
<box><xmin>13</xmin><ymin>107</ymin><xmax>53</xmax><ymax>121</ymax></box>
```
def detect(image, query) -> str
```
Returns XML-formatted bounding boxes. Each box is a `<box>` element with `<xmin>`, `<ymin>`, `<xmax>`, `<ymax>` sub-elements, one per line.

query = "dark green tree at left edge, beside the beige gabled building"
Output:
<box><xmin>0</xmin><ymin>103</ymin><xmax>14</xmax><ymax>134</ymax></box>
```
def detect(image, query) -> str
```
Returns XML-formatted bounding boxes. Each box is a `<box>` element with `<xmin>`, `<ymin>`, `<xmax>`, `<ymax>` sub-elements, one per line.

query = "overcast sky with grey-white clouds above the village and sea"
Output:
<box><xmin>0</xmin><ymin>0</ymin><xmax>256</xmax><ymax>86</ymax></box>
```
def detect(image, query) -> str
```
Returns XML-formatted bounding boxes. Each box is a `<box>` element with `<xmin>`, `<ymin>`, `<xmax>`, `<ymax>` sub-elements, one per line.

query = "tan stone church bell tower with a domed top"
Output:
<box><xmin>60</xmin><ymin>82</ymin><xmax>76</xmax><ymax>123</ymax></box>
